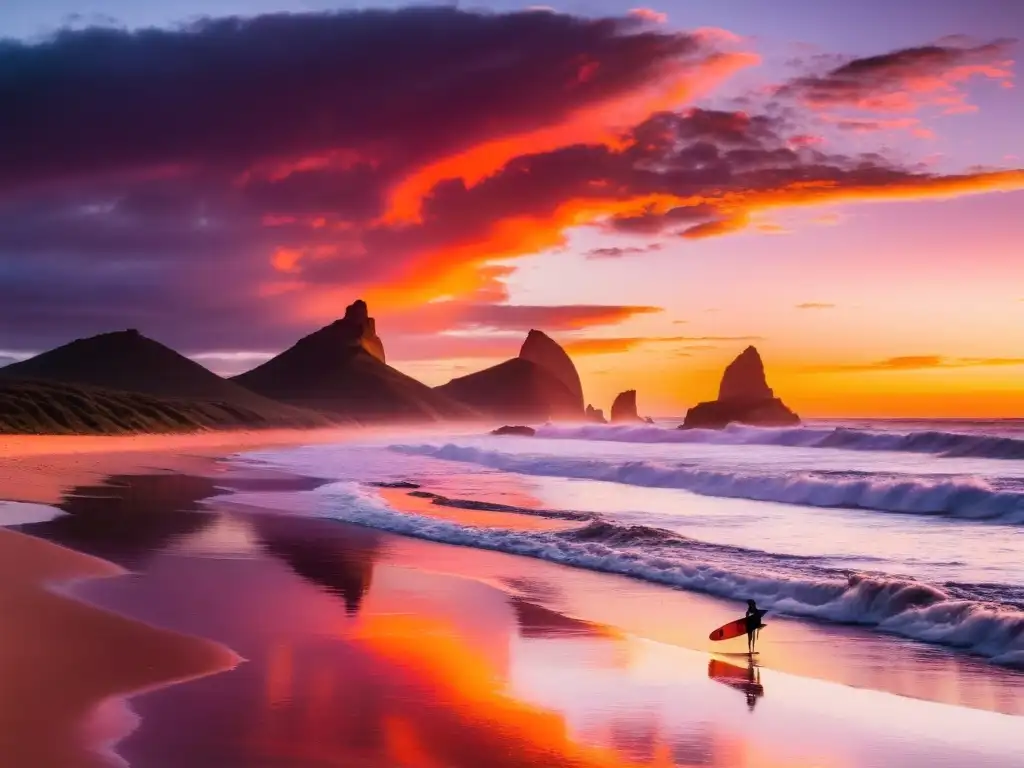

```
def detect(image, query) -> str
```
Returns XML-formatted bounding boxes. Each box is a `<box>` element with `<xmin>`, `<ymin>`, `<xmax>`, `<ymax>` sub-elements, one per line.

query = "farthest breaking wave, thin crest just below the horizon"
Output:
<box><xmin>537</xmin><ymin>425</ymin><xmax>1024</xmax><ymax>459</ymax></box>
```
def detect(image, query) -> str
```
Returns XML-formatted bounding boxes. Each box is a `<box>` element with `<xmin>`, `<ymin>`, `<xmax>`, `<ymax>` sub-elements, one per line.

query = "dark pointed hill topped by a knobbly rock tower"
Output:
<box><xmin>233</xmin><ymin>300</ymin><xmax>478</xmax><ymax>422</ymax></box>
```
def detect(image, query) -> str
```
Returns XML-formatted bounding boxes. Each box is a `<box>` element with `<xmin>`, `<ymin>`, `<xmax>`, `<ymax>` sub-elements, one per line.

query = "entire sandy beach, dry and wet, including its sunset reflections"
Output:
<box><xmin>0</xmin><ymin>434</ymin><xmax>1024</xmax><ymax>768</ymax></box>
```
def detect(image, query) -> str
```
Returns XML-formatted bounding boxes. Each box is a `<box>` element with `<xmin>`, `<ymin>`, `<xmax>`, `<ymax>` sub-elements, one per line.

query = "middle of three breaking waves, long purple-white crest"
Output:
<box><xmin>390</xmin><ymin>443</ymin><xmax>1024</xmax><ymax>523</ymax></box>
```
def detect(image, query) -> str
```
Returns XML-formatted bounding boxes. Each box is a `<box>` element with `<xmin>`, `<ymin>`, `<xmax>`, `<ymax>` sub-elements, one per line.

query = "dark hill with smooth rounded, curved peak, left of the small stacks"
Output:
<box><xmin>435</xmin><ymin>331</ymin><xmax>584</xmax><ymax>423</ymax></box>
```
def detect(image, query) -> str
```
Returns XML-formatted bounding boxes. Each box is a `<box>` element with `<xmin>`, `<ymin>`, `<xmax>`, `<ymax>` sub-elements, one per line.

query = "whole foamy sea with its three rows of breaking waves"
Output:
<box><xmin>237</xmin><ymin>421</ymin><xmax>1024</xmax><ymax>668</ymax></box>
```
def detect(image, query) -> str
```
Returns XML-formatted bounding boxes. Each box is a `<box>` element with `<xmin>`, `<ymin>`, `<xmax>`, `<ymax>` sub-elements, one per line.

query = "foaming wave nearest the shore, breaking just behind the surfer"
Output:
<box><xmin>310</xmin><ymin>482</ymin><xmax>1024</xmax><ymax>667</ymax></box>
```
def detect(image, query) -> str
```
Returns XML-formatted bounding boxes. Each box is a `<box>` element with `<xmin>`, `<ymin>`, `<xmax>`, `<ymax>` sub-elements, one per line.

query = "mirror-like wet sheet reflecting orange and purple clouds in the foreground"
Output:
<box><xmin>59</xmin><ymin>511</ymin><xmax>1018</xmax><ymax>768</ymax></box>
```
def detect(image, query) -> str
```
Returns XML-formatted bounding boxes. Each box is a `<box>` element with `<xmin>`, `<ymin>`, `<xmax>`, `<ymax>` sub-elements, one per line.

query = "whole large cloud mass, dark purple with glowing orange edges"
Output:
<box><xmin>0</xmin><ymin>8</ymin><xmax>1022</xmax><ymax>361</ymax></box>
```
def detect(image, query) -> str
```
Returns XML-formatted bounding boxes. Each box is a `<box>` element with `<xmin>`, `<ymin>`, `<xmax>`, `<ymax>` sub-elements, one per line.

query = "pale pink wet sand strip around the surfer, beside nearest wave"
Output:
<box><xmin>358</xmin><ymin>481</ymin><xmax>1024</xmax><ymax>716</ymax></box>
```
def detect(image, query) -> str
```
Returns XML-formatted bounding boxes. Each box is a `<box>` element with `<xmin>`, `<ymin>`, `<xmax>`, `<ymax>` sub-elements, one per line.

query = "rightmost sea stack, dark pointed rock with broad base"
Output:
<box><xmin>680</xmin><ymin>346</ymin><xmax>800</xmax><ymax>429</ymax></box>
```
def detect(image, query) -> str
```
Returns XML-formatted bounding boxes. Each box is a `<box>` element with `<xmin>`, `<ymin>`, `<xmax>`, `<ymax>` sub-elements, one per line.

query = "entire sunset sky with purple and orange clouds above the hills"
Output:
<box><xmin>0</xmin><ymin>0</ymin><xmax>1024</xmax><ymax>417</ymax></box>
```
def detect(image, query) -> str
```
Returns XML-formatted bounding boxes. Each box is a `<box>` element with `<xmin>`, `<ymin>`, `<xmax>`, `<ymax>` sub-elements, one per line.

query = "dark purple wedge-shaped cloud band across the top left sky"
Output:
<box><xmin>0</xmin><ymin>8</ymin><xmax>698</xmax><ymax>186</ymax></box>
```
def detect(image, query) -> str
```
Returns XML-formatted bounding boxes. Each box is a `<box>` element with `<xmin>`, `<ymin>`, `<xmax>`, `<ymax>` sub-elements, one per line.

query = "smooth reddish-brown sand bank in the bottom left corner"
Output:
<box><xmin>0</xmin><ymin>530</ymin><xmax>237</xmax><ymax>768</ymax></box>
